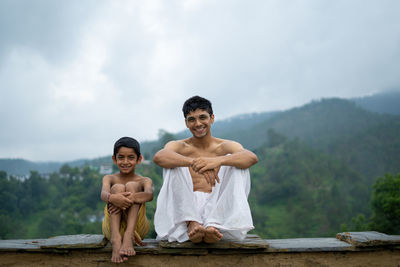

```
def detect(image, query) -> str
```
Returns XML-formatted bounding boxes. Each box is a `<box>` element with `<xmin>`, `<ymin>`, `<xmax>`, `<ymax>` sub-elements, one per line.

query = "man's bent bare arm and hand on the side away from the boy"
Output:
<box><xmin>192</xmin><ymin>140</ymin><xmax>258</xmax><ymax>173</ymax></box>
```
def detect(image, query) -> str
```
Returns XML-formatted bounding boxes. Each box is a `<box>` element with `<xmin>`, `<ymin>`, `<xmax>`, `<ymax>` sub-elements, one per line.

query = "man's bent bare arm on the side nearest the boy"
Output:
<box><xmin>153</xmin><ymin>141</ymin><xmax>193</xmax><ymax>169</ymax></box>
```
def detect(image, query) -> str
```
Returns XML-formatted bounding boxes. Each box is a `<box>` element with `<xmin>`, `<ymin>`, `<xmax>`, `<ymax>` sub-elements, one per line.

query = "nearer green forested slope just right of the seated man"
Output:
<box><xmin>250</xmin><ymin>130</ymin><xmax>370</xmax><ymax>238</ymax></box>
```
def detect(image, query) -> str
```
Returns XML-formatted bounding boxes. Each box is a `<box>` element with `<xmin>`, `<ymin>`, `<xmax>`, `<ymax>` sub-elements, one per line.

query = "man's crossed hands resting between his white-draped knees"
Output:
<box><xmin>190</xmin><ymin>157</ymin><xmax>221</xmax><ymax>186</ymax></box>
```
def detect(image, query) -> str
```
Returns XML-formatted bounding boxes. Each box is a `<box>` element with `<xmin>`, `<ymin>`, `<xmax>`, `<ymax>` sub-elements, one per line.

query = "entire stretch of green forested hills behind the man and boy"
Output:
<box><xmin>0</xmin><ymin>92</ymin><xmax>400</xmax><ymax>241</ymax></box>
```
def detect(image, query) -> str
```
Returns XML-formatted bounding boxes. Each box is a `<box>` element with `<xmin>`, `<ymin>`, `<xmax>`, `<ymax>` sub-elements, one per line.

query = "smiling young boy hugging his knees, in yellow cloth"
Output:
<box><xmin>100</xmin><ymin>137</ymin><xmax>153</xmax><ymax>263</ymax></box>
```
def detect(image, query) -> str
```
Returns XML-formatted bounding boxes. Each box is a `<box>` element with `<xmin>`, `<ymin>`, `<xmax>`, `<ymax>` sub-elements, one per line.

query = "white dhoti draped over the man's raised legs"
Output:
<box><xmin>154</xmin><ymin>166</ymin><xmax>254</xmax><ymax>242</ymax></box>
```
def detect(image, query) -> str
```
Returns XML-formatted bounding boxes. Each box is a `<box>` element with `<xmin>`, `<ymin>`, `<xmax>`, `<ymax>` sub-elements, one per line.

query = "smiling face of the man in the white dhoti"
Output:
<box><xmin>185</xmin><ymin>109</ymin><xmax>214</xmax><ymax>138</ymax></box>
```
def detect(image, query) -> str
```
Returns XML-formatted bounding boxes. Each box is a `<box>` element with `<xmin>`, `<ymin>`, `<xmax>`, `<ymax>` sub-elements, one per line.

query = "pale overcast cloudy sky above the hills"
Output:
<box><xmin>0</xmin><ymin>0</ymin><xmax>400</xmax><ymax>161</ymax></box>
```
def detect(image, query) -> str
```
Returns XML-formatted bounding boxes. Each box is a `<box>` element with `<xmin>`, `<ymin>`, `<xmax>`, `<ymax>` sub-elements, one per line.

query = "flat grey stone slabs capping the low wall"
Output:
<box><xmin>0</xmin><ymin>232</ymin><xmax>400</xmax><ymax>255</ymax></box>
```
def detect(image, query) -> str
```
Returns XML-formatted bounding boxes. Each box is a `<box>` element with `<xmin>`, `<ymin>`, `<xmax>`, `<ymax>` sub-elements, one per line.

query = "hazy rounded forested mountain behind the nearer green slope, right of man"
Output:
<box><xmin>212</xmin><ymin>99</ymin><xmax>400</xmax><ymax>184</ymax></box>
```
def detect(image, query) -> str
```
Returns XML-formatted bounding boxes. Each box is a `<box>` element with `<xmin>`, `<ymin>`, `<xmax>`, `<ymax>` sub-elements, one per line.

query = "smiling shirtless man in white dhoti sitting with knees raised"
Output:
<box><xmin>154</xmin><ymin>96</ymin><xmax>258</xmax><ymax>243</ymax></box>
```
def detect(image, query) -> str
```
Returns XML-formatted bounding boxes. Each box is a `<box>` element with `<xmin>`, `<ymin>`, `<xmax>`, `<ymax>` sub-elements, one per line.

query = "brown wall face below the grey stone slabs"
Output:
<box><xmin>0</xmin><ymin>250</ymin><xmax>400</xmax><ymax>267</ymax></box>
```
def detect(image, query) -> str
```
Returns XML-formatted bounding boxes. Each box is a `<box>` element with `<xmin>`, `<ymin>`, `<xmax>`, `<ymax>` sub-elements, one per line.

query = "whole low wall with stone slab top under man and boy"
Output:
<box><xmin>0</xmin><ymin>232</ymin><xmax>400</xmax><ymax>267</ymax></box>
